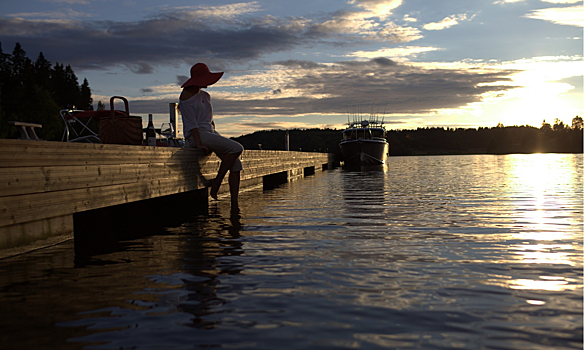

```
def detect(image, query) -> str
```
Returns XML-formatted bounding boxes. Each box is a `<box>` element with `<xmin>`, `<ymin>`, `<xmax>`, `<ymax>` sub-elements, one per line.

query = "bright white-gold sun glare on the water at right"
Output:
<box><xmin>489</xmin><ymin>154</ymin><xmax>583</xmax><ymax>292</ymax></box>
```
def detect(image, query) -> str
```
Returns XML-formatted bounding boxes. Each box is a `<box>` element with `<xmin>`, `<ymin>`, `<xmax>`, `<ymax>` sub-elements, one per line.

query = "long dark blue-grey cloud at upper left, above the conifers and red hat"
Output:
<box><xmin>0</xmin><ymin>13</ymin><xmax>306</xmax><ymax>72</ymax></box>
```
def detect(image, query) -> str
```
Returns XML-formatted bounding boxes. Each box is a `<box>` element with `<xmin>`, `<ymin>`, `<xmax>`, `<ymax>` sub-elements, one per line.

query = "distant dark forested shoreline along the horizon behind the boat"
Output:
<box><xmin>233</xmin><ymin>116</ymin><xmax>583</xmax><ymax>156</ymax></box>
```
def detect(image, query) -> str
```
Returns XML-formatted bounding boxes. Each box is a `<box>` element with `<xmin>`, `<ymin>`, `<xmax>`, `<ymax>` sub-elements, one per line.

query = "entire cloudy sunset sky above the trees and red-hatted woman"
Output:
<box><xmin>0</xmin><ymin>0</ymin><xmax>584</xmax><ymax>136</ymax></box>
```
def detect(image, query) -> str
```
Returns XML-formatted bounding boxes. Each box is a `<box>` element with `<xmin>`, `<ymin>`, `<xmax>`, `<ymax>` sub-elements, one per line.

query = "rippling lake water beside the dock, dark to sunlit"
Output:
<box><xmin>0</xmin><ymin>154</ymin><xmax>583</xmax><ymax>350</ymax></box>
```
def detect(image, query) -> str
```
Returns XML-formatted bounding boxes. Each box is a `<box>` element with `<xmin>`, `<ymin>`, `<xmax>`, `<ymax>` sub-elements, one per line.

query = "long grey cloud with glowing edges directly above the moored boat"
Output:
<box><xmin>214</xmin><ymin>58</ymin><xmax>513</xmax><ymax>116</ymax></box>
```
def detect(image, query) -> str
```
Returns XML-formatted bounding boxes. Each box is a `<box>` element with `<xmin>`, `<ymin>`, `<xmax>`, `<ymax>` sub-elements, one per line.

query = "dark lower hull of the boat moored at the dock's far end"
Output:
<box><xmin>339</xmin><ymin>140</ymin><xmax>389</xmax><ymax>165</ymax></box>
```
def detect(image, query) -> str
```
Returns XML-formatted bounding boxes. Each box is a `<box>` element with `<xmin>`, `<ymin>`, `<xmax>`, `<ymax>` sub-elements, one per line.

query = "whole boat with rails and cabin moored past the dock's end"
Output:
<box><xmin>339</xmin><ymin>120</ymin><xmax>389</xmax><ymax>166</ymax></box>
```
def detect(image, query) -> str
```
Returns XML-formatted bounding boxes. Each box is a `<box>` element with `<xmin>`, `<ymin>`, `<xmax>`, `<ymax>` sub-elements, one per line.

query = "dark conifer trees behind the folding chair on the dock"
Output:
<box><xmin>0</xmin><ymin>43</ymin><xmax>93</xmax><ymax>140</ymax></box>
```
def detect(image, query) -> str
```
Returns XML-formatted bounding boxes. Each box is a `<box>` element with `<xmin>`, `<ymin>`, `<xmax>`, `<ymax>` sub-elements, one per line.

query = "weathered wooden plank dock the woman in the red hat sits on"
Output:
<box><xmin>0</xmin><ymin>139</ymin><xmax>333</xmax><ymax>255</ymax></box>
